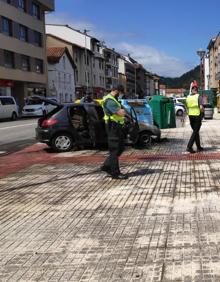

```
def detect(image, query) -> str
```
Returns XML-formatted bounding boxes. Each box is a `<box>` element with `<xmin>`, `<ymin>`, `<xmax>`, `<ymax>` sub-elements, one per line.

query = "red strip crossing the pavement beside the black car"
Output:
<box><xmin>0</xmin><ymin>144</ymin><xmax>220</xmax><ymax>178</ymax></box>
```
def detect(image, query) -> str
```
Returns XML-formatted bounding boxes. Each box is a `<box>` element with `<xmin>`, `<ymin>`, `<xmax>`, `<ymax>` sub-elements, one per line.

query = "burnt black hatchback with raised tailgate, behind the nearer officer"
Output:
<box><xmin>35</xmin><ymin>97</ymin><xmax>153</xmax><ymax>152</ymax></box>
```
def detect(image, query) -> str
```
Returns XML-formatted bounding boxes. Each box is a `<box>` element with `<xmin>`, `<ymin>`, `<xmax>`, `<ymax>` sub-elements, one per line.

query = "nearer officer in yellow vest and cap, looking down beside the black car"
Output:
<box><xmin>101</xmin><ymin>85</ymin><xmax>128</xmax><ymax>180</ymax></box>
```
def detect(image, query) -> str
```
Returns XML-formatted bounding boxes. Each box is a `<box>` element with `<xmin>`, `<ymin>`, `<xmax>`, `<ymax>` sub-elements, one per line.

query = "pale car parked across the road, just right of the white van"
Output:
<box><xmin>22</xmin><ymin>97</ymin><xmax>56</xmax><ymax>117</ymax></box>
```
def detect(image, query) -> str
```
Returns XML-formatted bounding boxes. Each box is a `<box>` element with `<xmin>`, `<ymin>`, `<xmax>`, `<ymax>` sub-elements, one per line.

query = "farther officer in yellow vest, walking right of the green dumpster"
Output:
<box><xmin>186</xmin><ymin>86</ymin><xmax>204</xmax><ymax>154</ymax></box>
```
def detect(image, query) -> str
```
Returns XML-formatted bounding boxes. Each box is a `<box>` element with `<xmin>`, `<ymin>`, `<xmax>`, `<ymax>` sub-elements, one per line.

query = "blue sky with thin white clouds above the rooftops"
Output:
<box><xmin>47</xmin><ymin>0</ymin><xmax>220</xmax><ymax>77</ymax></box>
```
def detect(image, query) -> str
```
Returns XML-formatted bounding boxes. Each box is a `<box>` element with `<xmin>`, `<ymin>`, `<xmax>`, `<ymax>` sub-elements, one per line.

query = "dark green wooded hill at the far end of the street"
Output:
<box><xmin>160</xmin><ymin>66</ymin><xmax>200</xmax><ymax>89</ymax></box>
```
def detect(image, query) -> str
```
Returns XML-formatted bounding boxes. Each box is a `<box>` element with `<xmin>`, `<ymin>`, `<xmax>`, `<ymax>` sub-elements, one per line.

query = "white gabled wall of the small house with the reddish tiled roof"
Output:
<box><xmin>48</xmin><ymin>54</ymin><xmax>76</xmax><ymax>103</ymax></box>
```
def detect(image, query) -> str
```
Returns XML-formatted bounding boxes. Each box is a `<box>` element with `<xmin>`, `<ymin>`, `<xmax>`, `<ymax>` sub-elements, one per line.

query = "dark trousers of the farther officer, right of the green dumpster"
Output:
<box><xmin>187</xmin><ymin>115</ymin><xmax>202</xmax><ymax>149</ymax></box>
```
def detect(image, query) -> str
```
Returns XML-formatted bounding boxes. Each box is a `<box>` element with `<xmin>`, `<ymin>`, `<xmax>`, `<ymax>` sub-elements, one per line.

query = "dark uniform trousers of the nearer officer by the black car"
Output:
<box><xmin>103</xmin><ymin>121</ymin><xmax>125</xmax><ymax>175</ymax></box>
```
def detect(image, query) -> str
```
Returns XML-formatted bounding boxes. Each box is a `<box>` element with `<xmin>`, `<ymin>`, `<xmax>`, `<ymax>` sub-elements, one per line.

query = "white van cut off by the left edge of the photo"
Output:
<box><xmin>0</xmin><ymin>96</ymin><xmax>18</xmax><ymax>120</ymax></box>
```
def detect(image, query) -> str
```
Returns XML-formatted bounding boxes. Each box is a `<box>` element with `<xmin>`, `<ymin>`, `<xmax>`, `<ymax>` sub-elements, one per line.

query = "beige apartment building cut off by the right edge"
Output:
<box><xmin>207</xmin><ymin>34</ymin><xmax>220</xmax><ymax>91</ymax></box>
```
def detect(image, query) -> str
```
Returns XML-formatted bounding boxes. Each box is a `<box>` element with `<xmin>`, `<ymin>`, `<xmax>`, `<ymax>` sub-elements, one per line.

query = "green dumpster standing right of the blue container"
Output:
<box><xmin>149</xmin><ymin>95</ymin><xmax>176</xmax><ymax>129</ymax></box>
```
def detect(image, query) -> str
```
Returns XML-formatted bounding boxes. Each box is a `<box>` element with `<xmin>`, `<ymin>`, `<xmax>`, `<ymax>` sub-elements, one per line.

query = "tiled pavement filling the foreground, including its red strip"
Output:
<box><xmin>0</xmin><ymin>114</ymin><xmax>220</xmax><ymax>282</ymax></box>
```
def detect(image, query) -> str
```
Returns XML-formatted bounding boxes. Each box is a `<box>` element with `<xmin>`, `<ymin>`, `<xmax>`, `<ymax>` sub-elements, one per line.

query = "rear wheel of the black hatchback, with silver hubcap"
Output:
<box><xmin>51</xmin><ymin>133</ymin><xmax>73</xmax><ymax>152</ymax></box>
